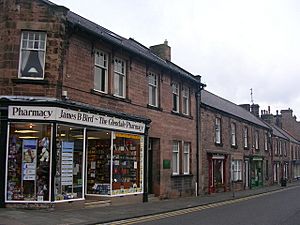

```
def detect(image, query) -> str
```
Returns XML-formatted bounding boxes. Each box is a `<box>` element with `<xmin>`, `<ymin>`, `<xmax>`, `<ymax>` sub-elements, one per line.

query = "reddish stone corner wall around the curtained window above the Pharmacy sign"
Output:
<box><xmin>0</xmin><ymin>0</ymin><xmax>66</xmax><ymax>97</ymax></box>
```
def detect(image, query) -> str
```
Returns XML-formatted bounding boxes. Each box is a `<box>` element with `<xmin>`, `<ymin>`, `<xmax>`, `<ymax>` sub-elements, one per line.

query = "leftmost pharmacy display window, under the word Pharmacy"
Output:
<box><xmin>6</xmin><ymin>123</ymin><xmax>52</xmax><ymax>202</ymax></box>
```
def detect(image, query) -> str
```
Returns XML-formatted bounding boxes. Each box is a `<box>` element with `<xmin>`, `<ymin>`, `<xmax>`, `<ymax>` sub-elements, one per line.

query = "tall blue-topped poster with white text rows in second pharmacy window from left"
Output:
<box><xmin>61</xmin><ymin>141</ymin><xmax>74</xmax><ymax>185</ymax></box>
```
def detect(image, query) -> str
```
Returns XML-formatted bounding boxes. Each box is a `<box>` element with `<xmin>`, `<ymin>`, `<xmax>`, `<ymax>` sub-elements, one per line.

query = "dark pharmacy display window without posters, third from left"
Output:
<box><xmin>87</xmin><ymin>130</ymin><xmax>111</xmax><ymax>195</ymax></box>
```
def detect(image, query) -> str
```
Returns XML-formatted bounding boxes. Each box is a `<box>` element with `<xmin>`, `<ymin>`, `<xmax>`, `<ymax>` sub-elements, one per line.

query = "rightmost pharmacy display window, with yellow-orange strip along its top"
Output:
<box><xmin>112</xmin><ymin>133</ymin><xmax>143</xmax><ymax>195</ymax></box>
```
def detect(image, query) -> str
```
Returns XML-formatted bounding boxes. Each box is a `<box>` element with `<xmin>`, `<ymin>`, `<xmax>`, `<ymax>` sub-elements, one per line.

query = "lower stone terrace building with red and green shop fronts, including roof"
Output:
<box><xmin>201</xmin><ymin>91</ymin><xmax>271</xmax><ymax>193</ymax></box>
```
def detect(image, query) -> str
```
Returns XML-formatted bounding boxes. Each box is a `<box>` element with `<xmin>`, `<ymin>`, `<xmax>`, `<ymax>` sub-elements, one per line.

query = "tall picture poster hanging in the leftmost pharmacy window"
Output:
<box><xmin>22</xmin><ymin>139</ymin><xmax>37</xmax><ymax>181</ymax></box>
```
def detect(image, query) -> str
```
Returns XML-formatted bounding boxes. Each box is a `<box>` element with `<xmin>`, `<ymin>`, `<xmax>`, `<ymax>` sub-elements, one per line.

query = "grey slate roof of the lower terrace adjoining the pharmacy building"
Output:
<box><xmin>201</xmin><ymin>90</ymin><xmax>270</xmax><ymax>129</ymax></box>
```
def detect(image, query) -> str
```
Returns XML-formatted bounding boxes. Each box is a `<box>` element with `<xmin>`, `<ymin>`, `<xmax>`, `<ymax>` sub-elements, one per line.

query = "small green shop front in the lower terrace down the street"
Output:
<box><xmin>250</xmin><ymin>156</ymin><xmax>263</xmax><ymax>188</ymax></box>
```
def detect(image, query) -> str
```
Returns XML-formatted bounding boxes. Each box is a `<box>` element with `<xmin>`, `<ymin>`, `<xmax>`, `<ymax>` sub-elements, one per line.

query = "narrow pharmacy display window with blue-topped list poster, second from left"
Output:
<box><xmin>54</xmin><ymin>125</ymin><xmax>84</xmax><ymax>201</ymax></box>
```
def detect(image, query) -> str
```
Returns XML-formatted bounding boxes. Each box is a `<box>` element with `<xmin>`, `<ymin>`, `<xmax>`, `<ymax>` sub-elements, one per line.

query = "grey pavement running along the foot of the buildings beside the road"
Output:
<box><xmin>0</xmin><ymin>181</ymin><xmax>300</xmax><ymax>225</ymax></box>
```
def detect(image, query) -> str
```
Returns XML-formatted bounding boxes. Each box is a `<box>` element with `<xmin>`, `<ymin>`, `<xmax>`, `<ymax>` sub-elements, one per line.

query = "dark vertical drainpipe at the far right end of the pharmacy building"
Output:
<box><xmin>195</xmin><ymin>75</ymin><xmax>206</xmax><ymax>196</ymax></box>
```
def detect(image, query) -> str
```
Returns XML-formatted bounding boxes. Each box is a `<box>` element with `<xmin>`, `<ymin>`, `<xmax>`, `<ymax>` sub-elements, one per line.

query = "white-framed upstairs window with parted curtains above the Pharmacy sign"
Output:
<box><xmin>19</xmin><ymin>31</ymin><xmax>46</xmax><ymax>79</ymax></box>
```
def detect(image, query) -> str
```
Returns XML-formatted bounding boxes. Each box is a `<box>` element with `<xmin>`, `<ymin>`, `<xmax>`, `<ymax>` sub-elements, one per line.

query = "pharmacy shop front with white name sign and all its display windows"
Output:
<box><xmin>1</xmin><ymin>101</ymin><xmax>149</xmax><ymax>206</ymax></box>
